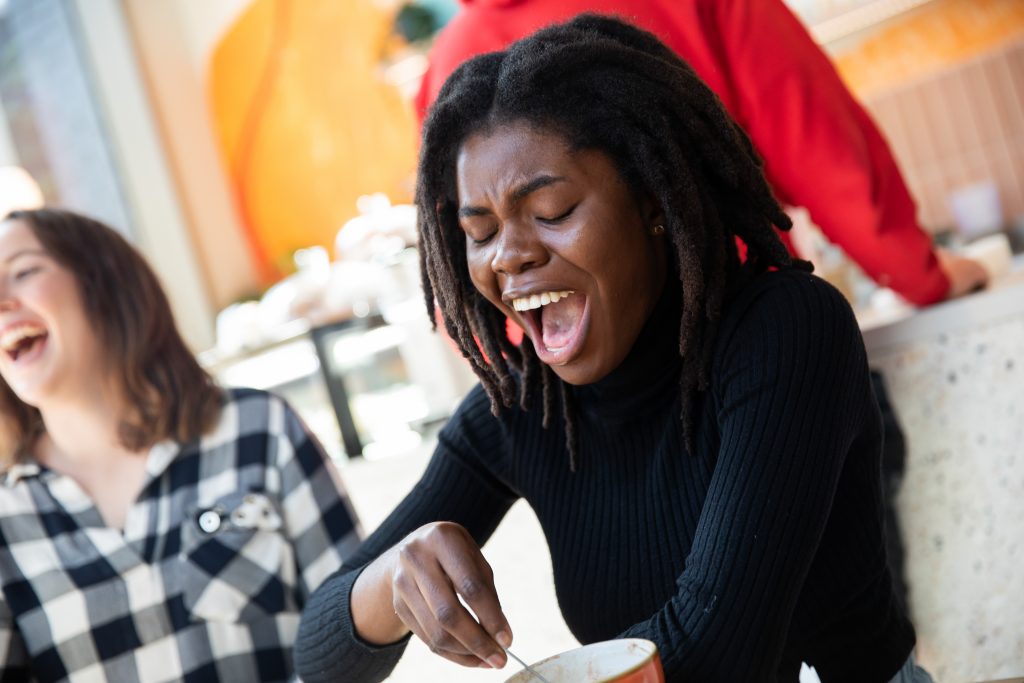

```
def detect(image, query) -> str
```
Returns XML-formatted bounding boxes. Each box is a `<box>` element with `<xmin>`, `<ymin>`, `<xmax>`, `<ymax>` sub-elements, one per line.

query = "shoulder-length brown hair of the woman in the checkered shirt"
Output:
<box><xmin>0</xmin><ymin>209</ymin><xmax>221</xmax><ymax>471</ymax></box>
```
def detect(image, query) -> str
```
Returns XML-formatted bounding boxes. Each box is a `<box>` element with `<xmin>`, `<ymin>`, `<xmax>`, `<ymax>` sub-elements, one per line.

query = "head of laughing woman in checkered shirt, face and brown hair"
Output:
<box><xmin>0</xmin><ymin>210</ymin><xmax>220</xmax><ymax>465</ymax></box>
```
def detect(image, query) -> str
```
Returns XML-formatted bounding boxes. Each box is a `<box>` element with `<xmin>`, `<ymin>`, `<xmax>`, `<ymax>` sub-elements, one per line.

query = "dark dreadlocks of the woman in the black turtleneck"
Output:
<box><xmin>416</xmin><ymin>14</ymin><xmax>811</xmax><ymax>470</ymax></box>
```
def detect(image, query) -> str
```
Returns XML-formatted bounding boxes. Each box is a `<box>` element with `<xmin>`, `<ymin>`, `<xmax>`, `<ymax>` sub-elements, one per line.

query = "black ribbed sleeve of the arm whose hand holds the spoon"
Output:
<box><xmin>295</xmin><ymin>387</ymin><xmax>517</xmax><ymax>683</ymax></box>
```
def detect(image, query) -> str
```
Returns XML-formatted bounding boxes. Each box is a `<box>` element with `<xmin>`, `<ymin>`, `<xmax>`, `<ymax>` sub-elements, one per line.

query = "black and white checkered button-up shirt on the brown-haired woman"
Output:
<box><xmin>0</xmin><ymin>389</ymin><xmax>359</xmax><ymax>683</ymax></box>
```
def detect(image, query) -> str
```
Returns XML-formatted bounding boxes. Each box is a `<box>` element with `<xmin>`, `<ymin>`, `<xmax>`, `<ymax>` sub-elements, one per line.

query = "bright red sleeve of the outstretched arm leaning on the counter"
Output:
<box><xmin>715</xmin><ymin>0</ymin><xmax>949</xmax><ymax>305</ymax></box>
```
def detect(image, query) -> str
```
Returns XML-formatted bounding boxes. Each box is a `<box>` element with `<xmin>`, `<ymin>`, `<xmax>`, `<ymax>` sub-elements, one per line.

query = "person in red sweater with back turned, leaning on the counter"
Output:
<box><xmin>416</xmin><ymin>0</ymin><xmax>987</xmax><ymax>305</ymax></box>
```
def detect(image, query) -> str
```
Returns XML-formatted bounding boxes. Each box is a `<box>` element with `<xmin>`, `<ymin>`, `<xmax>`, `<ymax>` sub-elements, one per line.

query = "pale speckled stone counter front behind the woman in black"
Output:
<box><xmin>864</xmin><ymin>252</ymin><xmax>1024</xmax><ymax>683</ymax></box>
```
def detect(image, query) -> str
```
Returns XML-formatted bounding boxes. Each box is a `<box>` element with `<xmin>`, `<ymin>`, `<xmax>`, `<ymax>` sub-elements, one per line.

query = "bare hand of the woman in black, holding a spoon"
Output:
<box><xmin>351</xmin><ymin>522</ymin><xmax>512</xmax><ymax>669</ymax></box>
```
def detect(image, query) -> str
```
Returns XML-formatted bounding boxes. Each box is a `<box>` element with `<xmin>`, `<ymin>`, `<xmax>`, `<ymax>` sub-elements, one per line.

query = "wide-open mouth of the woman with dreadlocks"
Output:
<box><xmin>512</xmin><ymin>290</ymin><xmax>587</xmax><ymax>365</ymax></box>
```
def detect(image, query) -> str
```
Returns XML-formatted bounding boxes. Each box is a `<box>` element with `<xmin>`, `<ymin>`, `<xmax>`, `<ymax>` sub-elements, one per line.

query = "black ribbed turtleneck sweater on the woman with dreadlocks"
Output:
<box><xmin>295</xmin><ymin>271</ymin><xmax>914</xmax><ymax>683</ymax></box>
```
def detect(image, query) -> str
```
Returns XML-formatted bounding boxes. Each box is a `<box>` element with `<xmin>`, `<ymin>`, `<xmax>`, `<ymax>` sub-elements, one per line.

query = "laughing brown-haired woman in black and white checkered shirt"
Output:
<box><xmin>0</xmin><ymin>210</ymin><xmax>358</xmax><ymax>683</ymax></box>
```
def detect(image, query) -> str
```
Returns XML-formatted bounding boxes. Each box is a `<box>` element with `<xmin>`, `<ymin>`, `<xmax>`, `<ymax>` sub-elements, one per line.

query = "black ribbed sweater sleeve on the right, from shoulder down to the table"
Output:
<box><xmin>622</xmin><ymin>273</ymin><xmax>871</xmax><ymax>683</ymax></box>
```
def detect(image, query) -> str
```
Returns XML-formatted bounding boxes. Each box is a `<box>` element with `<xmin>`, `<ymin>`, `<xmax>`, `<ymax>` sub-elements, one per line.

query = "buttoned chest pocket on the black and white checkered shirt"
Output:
<box><xmin>181</xmin><ymin>492</ymin><xmax>298</xmax><ymax>622</ymax></box>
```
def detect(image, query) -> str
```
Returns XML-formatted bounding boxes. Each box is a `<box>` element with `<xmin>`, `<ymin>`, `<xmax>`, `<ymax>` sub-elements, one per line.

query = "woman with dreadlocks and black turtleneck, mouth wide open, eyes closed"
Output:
<box><xmin>296</xmin><ymin>16</ymin><xmax>914</xmax><ymax>683</ymax></box>
